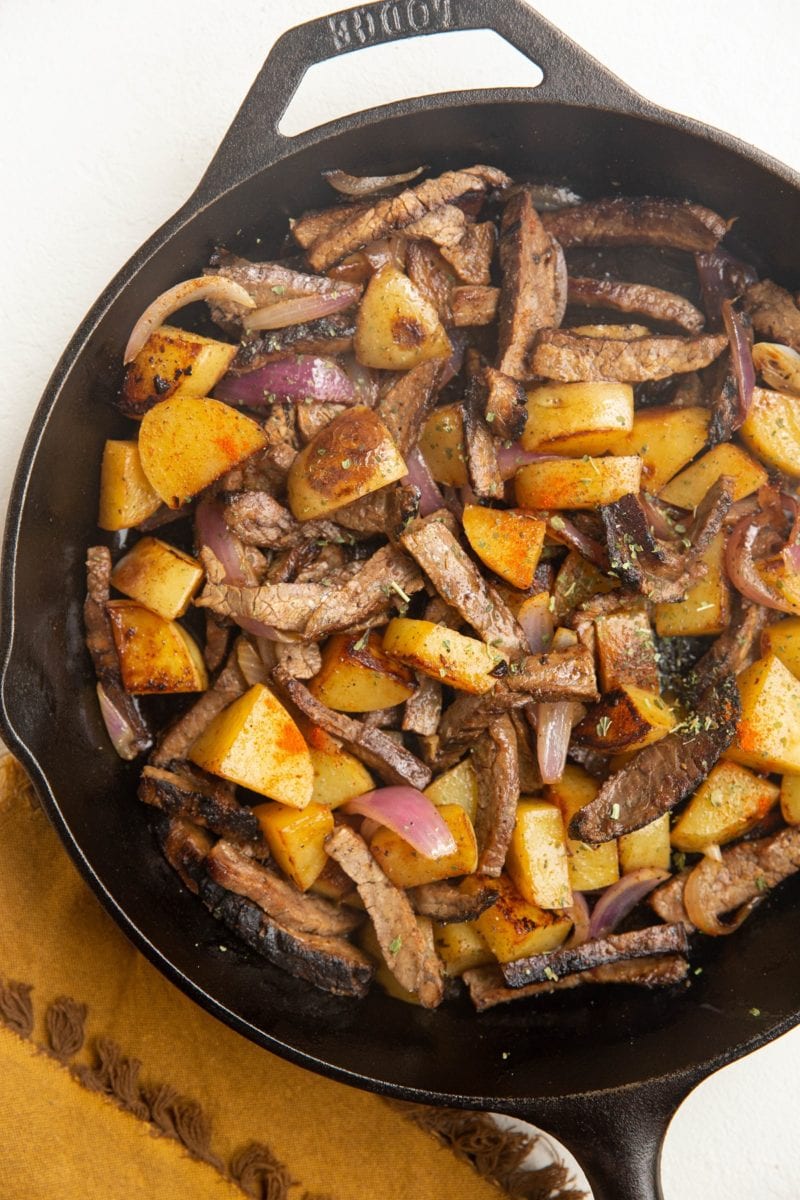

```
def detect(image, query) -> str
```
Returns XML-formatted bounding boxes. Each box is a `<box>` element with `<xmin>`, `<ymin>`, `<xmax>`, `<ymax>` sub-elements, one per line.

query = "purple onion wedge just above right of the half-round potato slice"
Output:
<box><xmin>213</xmin><ymin>354</ymin><xmax>356</xmax><ymax>408</ymax></box>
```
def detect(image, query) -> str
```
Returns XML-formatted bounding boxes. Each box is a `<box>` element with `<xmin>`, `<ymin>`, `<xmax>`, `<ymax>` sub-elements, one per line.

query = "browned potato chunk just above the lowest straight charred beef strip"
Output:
<box><xmin>472</xmin><ymin>875</ymin><xmax>572</xmax><ymax>962</ymax></box>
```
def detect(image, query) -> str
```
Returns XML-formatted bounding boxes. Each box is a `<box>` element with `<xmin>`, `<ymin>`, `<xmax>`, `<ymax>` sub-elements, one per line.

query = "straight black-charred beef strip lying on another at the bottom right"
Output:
<box><xmin>500</xmin><ymin>924</ymin><xmax>688</xmax><ymax>988</ymax></box>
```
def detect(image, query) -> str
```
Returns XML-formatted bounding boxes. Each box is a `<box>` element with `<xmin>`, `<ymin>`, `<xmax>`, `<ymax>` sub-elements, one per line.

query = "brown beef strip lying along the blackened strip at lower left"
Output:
<box><xmin>205</xmin><ymin>840</ymin><xmax>361</xmax><ymax>936</ymax></box>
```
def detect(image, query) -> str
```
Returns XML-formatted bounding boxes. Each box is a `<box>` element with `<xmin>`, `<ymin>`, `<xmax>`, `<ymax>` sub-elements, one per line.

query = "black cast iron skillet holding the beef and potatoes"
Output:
<box><xmin>0</xmin><ymin>0</ymin><xmax>800</xmax><ymax>1200</ymax></box>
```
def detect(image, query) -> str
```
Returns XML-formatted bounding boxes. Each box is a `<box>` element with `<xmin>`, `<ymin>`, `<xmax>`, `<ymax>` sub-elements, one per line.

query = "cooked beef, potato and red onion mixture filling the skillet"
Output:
<box><xmin>85</xmin><ymin>166</ymin><xmax>800</xmax><ymax>1010</ymax></box>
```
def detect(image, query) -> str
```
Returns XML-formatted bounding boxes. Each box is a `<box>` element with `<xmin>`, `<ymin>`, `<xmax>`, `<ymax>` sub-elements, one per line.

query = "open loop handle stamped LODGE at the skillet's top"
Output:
<box><xmin>196</xmin><ymin>0</ymin><xmax>655</xmax><ymax>200</ymax></box>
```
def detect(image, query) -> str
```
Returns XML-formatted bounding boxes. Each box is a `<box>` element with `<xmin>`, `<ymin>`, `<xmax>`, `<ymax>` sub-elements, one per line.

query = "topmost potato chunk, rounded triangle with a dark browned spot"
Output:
<box><xmin>353</xmin><ymin>265</ymin><xmax>452</xmax><ymax>371</ymax></box>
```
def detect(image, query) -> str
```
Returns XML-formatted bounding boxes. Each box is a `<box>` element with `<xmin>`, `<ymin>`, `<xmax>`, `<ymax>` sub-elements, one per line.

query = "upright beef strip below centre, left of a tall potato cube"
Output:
<box><xmin>473</xmin><ymin>715</ymin><xmax>519</xmax><ymax>878</ymax></box>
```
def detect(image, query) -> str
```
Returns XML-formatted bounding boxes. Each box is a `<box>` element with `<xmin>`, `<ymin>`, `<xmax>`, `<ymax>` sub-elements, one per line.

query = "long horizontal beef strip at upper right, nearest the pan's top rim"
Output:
<box><xmin>542</xmin><ymin>196</ymin><xmax>728</xmax><ymax>251</ymax></box>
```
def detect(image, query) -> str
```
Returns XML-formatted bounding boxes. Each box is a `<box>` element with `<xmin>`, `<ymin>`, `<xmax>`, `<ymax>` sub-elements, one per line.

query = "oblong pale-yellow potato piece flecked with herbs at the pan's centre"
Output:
<box><xmin>384</xmin><ymin>617</ymin><xmax>505</xmax><ymax>695</ymax></box>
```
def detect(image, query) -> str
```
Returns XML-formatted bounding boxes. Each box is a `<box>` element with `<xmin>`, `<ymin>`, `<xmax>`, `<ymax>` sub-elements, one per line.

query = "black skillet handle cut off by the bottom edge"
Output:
<box><xmin>507</xmin><ymin>1074</ymin><xmax>698</xmax><ymax>1200</ymax></box>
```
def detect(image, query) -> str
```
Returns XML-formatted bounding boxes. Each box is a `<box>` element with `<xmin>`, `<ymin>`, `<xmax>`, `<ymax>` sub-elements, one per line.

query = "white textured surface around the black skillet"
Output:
<box><xmin>0</xmin><ymin>0</ymin><xmax>800</xmax><ymax>1200</ymax></box>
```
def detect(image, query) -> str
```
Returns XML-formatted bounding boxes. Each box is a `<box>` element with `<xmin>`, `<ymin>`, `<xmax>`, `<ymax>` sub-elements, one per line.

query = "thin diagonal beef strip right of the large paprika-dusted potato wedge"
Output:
<box><xmin>275</xmin><ymin>667</ymin><xmax>431</xmax><ymax>790</ymax></box>
